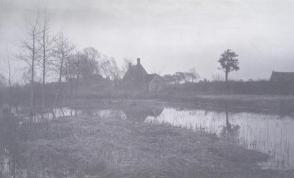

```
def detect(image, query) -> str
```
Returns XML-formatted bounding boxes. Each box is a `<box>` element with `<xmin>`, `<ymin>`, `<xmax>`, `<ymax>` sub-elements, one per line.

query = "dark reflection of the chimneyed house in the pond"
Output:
<box><xmin>123</xmin><ymin>106</ymin><xmax>163</xmax><ymax>122</ymax></box>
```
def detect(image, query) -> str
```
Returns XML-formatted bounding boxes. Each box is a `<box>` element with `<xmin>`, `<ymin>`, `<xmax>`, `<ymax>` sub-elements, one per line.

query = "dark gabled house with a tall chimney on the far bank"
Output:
<box><xmin>122</xmin><ymin>58</ymin><xmax>166</xmax><ymax>92</ymax></box>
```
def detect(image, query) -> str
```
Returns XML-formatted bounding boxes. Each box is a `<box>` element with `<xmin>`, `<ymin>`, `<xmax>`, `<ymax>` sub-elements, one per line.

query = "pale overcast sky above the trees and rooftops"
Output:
<box><xmin>0</xmin><ymin>0</ymin><xmax>294</xmax><ymax>82</ymax></box>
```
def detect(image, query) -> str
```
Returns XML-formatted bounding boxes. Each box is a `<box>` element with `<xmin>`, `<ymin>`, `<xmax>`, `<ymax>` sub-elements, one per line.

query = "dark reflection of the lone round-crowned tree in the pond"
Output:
<box><xmin>221</xmin><ymin>110</ymin><xmax>240</xmax><ymax>139</ymax></box>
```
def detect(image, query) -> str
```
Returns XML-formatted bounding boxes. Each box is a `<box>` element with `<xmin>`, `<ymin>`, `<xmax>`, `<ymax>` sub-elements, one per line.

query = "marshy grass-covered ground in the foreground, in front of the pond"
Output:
<box><xmin>25</xmin><ymin>112</ymin><xmax>294</xmax><ymax>178</ymax></box>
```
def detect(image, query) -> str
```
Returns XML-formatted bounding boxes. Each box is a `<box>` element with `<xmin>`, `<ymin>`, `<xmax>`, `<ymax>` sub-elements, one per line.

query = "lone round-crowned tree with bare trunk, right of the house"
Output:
<box><xmin>218</xmin><ymin>49</ymin><xmax>240</xmax><ymax>82</ymax></box>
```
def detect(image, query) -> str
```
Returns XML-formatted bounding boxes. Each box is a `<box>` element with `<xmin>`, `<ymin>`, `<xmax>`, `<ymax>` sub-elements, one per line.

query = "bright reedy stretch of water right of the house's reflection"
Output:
<box><xmin>145</xmin><ymin>108</ymin><xmax>294</xmax><ymax>169</ymax></box>
